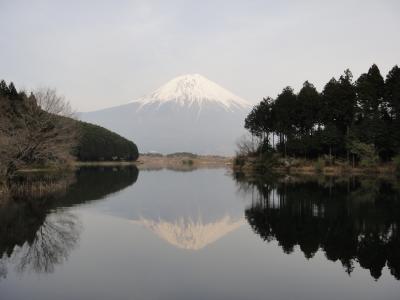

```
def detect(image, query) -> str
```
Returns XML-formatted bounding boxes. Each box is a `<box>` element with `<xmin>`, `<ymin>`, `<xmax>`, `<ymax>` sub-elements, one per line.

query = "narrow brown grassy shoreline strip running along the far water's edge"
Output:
<box><xmin>14</xmin><ymin>155</ymin><xmax>397</xmax><ymax>177</ymax></box>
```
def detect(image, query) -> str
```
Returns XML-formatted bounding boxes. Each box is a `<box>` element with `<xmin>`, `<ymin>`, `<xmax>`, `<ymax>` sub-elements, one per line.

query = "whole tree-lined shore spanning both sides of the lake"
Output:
<box><xmin>0</xmin><ymin>65</ymin><xmax>400</xmax><ymax>180</ymax></box>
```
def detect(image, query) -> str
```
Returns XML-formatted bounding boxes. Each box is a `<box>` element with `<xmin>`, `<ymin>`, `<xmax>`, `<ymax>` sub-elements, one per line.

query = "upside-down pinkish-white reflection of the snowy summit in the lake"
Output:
<box><xmin>133</xmin><ymin>216</ymin><xmax>244</xmax><ymax>250</ymax></box>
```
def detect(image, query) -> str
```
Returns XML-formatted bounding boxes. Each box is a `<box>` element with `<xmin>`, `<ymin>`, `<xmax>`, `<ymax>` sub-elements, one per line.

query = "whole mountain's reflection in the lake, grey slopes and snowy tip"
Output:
<box><xmin>98</xmin><ymin>169</ymin><xmax>244</xmax><ymax>250</ymax></box>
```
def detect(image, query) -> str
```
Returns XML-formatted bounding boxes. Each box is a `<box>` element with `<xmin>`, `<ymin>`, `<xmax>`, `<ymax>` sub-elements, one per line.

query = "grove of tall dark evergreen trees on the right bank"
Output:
<box><xmin>245</xmin><ymin>64</ymin><xmax>400</xmax><ymax>166</ymax></box>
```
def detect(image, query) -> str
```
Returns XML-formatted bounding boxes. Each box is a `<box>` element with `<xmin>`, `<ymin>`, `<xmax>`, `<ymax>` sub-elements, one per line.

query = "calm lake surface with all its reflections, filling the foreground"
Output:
<box><xmin>0</xmin><ymin>168</ymin><xmax>400</xmax><ymax>300</ymax></box>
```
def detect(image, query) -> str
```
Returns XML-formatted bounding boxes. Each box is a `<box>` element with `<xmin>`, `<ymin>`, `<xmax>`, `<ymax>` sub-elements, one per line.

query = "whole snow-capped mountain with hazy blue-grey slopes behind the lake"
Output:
<box><xmin>81</xmin><ymin>74</ymin><xmax>251</xmax><ymax>155</ymax></box>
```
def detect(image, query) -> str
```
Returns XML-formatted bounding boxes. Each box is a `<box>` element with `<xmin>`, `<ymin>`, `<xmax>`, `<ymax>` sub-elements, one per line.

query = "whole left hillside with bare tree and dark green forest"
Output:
<box><xmin>0</xmin><ymin>80</ymin><xmax>138</xmax><ymax>177</ymax></box>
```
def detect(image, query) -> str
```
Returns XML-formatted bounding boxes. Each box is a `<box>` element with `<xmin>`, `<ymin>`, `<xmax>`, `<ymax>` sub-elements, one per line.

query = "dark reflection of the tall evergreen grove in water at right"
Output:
<box><xmin>234</xmin><ymin>178</ymin><xmax>400</xmax><ymax>280</ymax></box>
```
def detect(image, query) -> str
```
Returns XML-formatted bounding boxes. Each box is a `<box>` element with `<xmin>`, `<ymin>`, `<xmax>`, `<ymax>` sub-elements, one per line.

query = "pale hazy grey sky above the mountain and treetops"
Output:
<box><xmin>0</xmin><ymin>0</ymin><xmax>400</xmax><ymax>111</ymax></box>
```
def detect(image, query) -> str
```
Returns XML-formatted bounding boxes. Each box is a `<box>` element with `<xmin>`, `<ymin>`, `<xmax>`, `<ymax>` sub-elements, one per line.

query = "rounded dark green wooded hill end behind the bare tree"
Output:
<box><xmin>76</xmin><ymin>122</ymin><xmax>139</xmax><ymax>161</ymax></box>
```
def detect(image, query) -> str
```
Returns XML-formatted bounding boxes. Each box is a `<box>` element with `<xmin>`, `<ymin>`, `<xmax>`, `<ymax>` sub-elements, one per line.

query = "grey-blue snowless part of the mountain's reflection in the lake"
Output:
<box><xmin>89</xmin><ymin>169</ymin><xmax>245</xmax><ymax>223</ymax></box>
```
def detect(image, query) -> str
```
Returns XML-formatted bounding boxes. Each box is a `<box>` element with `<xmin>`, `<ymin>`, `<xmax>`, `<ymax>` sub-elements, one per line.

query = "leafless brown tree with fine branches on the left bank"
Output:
<box><xmin>0</xmin><ymin>89</ymin><xmax>78</xmax><ymax>177</ymax></box>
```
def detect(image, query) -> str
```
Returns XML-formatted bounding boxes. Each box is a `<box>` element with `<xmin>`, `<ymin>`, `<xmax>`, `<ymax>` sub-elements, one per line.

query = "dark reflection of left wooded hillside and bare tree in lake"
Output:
<box><xmin>0</xmin><ymin>168</ymin><xmax>138</xmax><ymax>278</ymax></box>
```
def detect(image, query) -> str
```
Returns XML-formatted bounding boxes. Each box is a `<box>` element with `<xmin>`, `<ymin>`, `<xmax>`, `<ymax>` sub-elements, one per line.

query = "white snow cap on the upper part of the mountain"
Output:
<box><xmin>132</xmin><ymin>74</ymin><xmax>250</xmax><ymax>111</ymax></box>
